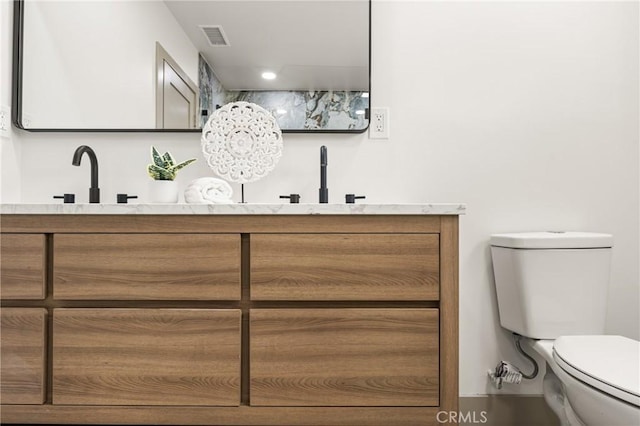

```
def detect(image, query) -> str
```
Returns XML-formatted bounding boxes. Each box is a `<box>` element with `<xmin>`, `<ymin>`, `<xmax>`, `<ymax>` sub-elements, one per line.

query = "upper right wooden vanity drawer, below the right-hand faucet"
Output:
<box><xmin>251</xmin><ymin>234</ymin><xmax>440</xmax><ymax>300</ymax></box>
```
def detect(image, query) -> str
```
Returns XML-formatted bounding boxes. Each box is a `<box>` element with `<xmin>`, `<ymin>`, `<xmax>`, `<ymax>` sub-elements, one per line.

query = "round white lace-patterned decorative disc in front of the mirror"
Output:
<box><xmin>201</xmin><ymin>102</ymin><xmax>282</xmax><ymax>183</ymax></box>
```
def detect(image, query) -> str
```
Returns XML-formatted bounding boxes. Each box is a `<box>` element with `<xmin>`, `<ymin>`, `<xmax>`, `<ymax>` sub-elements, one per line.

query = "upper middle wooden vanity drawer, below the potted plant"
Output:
<box><xmin>53</xmin><ymin>234</ymin><xmax>240</xmax><ymax>300</ymax></box>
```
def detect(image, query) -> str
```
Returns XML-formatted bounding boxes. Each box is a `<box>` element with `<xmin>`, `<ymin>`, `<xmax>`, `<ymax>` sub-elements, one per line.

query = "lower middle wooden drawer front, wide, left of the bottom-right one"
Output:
<box><xmin>53</xmin><ymin>309</ymin><xmax>240</xmax><ymax>406</ymax></box>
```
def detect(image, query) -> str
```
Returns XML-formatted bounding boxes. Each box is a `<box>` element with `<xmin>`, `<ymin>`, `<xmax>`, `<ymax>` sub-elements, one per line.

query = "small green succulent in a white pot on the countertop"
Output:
<box><xmin>147</xmin><ymin>146</ymin><xmax>196</xmax><ymax>203</ymax></box>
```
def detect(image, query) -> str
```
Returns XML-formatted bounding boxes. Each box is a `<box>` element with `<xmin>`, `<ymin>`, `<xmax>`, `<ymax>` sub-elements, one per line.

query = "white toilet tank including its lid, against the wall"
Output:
<box><xmin>491</xmin><ymin>232</ymin><xmax>613</xmax><ymax>339</ymax></box>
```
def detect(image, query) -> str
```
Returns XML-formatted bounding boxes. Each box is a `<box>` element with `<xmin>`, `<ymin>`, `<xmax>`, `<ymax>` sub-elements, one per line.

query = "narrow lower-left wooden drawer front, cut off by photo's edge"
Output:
<box><xmin>0</xmin><ymin>308</ymin><xmax>47</xmax><ymax>404</ymax></box>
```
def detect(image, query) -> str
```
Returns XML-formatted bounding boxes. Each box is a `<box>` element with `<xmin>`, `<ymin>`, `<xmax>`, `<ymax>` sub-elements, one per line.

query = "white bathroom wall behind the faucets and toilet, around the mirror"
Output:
<box><xmin>2</xmin><ymin>0</ymin><xmax>640</xmax><ymax>395</ymax></box>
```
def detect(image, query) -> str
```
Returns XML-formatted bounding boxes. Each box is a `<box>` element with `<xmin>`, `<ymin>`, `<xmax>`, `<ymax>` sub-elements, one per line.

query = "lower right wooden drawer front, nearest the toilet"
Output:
<box><xmin>250</xmin><ymin>309</ymin><xmax>439</xmax><ymax>406</ymax></box>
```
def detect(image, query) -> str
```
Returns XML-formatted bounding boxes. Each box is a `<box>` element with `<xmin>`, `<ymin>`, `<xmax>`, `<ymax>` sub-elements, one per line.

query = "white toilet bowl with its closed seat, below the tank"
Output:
<box><xmin>526</xmin><ymin>336</ymin><xmax>640</xmax><ymax>426</ymax></box>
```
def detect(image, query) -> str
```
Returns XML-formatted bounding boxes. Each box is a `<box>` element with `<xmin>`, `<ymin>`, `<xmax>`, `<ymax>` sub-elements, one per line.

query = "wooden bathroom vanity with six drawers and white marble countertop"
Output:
<box><xmin>0</xmin><ymin>204</ymin><xmax>464</xmax><ymax>426</ymax></box>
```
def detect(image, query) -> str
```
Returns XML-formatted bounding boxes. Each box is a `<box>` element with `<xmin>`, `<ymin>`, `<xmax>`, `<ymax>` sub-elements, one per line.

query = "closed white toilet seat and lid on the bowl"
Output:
<box><xmin>553</xmin><ymin>336</ymin><xmax>640</xmax><ymax>407</ymax></box>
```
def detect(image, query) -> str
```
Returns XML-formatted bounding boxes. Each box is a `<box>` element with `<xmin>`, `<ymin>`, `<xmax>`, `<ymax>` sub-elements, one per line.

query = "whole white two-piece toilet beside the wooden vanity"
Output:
<box><xmin>491</xmin><ymin>232</ymin><xmax>640</xmax><ymax>426</ymax></box>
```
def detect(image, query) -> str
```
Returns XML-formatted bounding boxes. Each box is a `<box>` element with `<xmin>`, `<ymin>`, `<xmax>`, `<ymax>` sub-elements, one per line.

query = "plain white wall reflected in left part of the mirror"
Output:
<box><xmin>23</xmin><ymin>0</ymin><xmax>198</xmax><ymax>129</ymax></box>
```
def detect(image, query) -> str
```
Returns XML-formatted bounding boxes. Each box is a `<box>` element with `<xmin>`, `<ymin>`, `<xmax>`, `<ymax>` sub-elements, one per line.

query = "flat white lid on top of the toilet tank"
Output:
<box><xmin>491</xmin><ymin>231</ymin><xmax>613</xmax><ymax>249</ymax></box>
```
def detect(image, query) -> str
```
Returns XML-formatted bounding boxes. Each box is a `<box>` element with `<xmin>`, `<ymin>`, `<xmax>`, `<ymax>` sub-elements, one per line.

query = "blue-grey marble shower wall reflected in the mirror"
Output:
<box><xmin>198</xmin><ymin>56</ymin><xmax>369</xmax><ymax>130</ymax></box>
